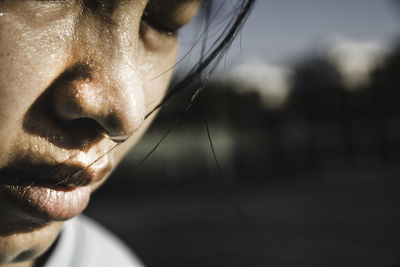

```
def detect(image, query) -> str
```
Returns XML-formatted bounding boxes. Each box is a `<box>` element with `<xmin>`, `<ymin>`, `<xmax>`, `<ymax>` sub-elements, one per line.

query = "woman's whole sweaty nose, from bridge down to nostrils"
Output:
<box><xmin>55</xmin><ymin>16</ymin><xmax>145</xmax><ymax>142</ymax></box>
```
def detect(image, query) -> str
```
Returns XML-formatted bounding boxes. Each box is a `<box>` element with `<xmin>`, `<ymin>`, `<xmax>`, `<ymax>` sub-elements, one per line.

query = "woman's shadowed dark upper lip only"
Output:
<box><xmin>0</xmin><ymin>159</ymin><xmax>110</xmax><ymax>189</ymax></box>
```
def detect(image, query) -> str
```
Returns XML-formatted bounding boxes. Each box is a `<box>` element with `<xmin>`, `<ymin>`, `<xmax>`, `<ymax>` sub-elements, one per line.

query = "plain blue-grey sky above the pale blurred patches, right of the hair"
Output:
<box><xmin>228</xmin><ymin>0</ymin><xmax>400</xmax><ymax>65</ymax></box>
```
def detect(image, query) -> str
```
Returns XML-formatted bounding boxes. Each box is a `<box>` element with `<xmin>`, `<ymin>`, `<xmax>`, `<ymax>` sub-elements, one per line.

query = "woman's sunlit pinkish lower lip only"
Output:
<box><xmin>2</xmin><ymin>185</ymin><xmax>91</xmax><ymax>221</ymax></box>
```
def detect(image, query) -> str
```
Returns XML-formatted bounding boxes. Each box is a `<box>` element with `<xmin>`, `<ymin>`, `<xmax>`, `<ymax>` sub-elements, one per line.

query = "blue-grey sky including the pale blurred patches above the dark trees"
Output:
<box><xmin>178</xmin><ymin>0</ymin><xmax>400</xmax><ymax>103</ymax></box>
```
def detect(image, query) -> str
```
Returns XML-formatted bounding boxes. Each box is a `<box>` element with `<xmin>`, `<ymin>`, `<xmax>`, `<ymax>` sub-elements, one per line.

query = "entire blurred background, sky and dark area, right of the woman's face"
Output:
<box><xmin>86</xmin><ymin>0</ymin><xmax>400</xmax><ymax>267</ymax></box>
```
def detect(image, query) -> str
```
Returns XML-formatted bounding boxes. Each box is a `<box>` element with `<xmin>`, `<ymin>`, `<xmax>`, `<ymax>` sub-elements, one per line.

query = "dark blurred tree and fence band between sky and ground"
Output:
<box><xmin>104</xmin><ymin>43</ymin><xmax>400</xmax><ymax>187</ymax></box>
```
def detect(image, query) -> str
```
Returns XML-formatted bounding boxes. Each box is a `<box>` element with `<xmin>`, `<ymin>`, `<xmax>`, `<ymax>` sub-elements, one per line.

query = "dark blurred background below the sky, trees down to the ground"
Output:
<box><xmin>86</xmin><ymin>43</ymin><xmax>400</xmax><ymax>267</ymax></box>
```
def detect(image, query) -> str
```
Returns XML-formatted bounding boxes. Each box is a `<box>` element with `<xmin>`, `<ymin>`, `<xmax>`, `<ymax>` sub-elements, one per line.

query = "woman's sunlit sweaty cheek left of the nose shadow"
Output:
<box><xmin>0</xmin><ymin>14</ymin><xmax>71</xmax><ymax>164</ymax></box>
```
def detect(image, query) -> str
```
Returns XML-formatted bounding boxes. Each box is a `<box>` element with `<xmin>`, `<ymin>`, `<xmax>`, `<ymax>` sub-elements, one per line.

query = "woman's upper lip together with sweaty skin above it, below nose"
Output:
<box><xmin>0</xmin><ymin>134</ymin><xmax>115</xmax><ymax>190</ymax></box>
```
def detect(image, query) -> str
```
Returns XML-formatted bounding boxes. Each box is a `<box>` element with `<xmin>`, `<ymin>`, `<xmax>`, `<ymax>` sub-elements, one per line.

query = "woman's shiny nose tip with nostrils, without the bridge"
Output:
<box><xmin>52</xmin><ymin>64</ymin><xmax>145</xmax><ymax>142</ymax></box>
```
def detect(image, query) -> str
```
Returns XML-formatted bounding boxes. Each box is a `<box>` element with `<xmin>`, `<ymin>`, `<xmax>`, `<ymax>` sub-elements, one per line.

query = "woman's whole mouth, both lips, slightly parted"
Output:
<box><xmin>0</xmin><ymin>156</ymin><xmax>112</xmax><ymax>222</ymax></box>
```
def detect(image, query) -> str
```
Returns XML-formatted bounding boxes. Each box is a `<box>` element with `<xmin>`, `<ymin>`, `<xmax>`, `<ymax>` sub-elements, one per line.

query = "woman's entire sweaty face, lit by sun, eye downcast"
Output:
<box><xmin>0</xmin><ymin>0</ymin><xmax>200</xmax><ymax>265</ymax></box>
